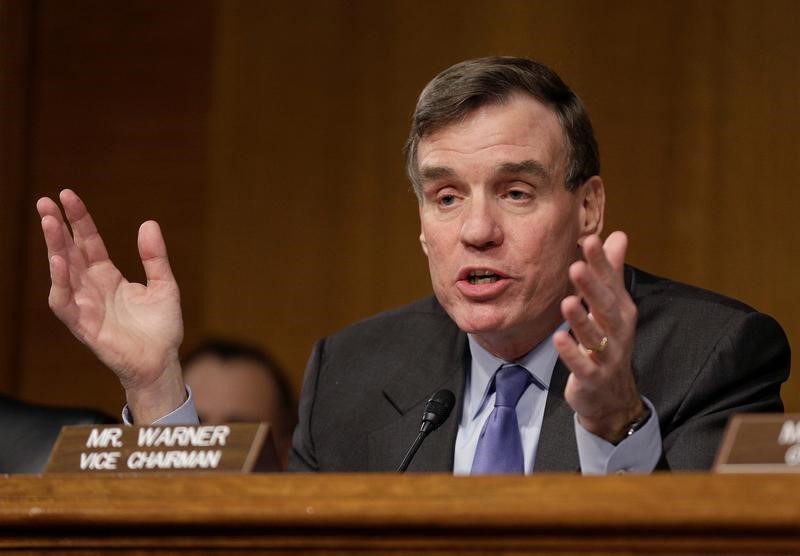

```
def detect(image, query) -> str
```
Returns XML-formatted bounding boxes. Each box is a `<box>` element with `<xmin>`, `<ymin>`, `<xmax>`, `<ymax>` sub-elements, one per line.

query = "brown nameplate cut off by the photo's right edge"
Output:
<box><xmin>713</xmin><ymin>413</ymin><xmax>800</xmax><ymax>473</ymax></box>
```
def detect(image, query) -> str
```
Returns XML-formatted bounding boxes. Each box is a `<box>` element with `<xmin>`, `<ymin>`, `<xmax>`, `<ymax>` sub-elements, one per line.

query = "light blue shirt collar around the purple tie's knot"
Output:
<box><xmin>467</xmin><ymin>321</ymin><xmax>569</xmax><ymax>419</ymax></box>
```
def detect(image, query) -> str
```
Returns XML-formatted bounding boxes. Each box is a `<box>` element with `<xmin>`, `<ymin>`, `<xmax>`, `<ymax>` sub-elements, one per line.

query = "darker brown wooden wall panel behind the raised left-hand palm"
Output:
<box><xmin>16</xmin><ymin>0</ymin><xmax>213</xmax><ymax>415</ymax></box>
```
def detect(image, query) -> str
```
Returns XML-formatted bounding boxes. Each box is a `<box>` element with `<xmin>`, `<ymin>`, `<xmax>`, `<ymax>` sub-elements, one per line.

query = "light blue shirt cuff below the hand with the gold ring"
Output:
<box><xmin>575</xmin><ymin>396</ymin><xmax>661</xmax><ymax>475</ymax></box>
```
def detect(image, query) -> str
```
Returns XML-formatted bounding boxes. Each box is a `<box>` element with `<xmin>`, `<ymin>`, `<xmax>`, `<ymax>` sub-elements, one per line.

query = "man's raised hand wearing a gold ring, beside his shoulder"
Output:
<box><xmin>553</xmin><ymin>232</ymin><xmax>644</xmax><ymax>443</ymax></box>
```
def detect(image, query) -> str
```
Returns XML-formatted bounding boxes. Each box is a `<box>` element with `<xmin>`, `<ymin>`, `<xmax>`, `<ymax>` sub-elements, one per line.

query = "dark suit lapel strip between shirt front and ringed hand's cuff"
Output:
<box><xmin>533</xmin><ymin>359</ymin><xmax>580</xmax><ymax>472</ymax></box>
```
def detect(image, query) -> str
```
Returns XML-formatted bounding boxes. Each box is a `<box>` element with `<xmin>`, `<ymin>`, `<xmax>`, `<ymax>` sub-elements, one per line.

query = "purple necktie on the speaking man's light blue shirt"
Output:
<box><xmin>472</xmin><ymin>365</ymin><xmax>533</xmax><ymax>475</ymax></box>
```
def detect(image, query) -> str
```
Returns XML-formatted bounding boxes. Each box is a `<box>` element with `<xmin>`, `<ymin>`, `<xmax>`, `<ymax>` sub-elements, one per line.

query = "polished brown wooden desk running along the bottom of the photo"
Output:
<box><xmin>0</xmin><ymin>474</ymin><xmax>800</xmax><ymax>554</ymax></box>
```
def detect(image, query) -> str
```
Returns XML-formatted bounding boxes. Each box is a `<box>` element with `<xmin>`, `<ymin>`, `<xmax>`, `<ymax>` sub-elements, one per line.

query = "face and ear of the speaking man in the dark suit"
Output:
<box><xmin>417</xmin><ymin>95</ymin><xmax>603</xmax><ymax>359</ymax></box>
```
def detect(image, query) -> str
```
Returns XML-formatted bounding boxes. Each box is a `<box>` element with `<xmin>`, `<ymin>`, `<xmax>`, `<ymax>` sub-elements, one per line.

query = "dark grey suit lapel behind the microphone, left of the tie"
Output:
<box><xmin>369</xmin><ymin>321</ymin><xmax>467</xmax><ymax>472</ymax></box>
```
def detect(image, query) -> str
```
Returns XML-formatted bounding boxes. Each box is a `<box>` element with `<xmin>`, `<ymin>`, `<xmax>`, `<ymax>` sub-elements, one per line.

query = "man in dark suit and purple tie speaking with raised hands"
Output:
<box><xmin>38</xmin><ymin>58</ymin><xmax>789</xmax><ymax>473</ymax></box>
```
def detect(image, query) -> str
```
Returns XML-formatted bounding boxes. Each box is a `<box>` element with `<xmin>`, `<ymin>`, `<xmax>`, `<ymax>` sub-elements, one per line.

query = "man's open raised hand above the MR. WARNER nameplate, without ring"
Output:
<box><xmin>36</xmin><ymin>189</ymin><xmax>186</xmax><ymax>424</ymax></box>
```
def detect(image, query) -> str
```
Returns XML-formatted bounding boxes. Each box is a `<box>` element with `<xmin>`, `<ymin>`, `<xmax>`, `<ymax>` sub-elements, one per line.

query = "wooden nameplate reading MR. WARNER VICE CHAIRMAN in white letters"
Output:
<box><xmin>45</xmin><ymin>423</ymin><xmax>280</xmax><ymax>473</ymax></box>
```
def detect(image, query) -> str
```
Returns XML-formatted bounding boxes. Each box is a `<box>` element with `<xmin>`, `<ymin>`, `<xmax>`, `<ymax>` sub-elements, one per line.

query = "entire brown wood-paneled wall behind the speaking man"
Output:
<box><xmin>0</xmin><ymin>0</ymin><xmax>800</xmax><ymax>414</ymax></box>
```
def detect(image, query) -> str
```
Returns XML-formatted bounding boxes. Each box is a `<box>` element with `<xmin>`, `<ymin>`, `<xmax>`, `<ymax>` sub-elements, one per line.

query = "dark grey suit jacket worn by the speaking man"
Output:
<box><xmin>289</xmin><ymin>267</ymin><xmax>790</xmax><ymax>471</ymax></box>
